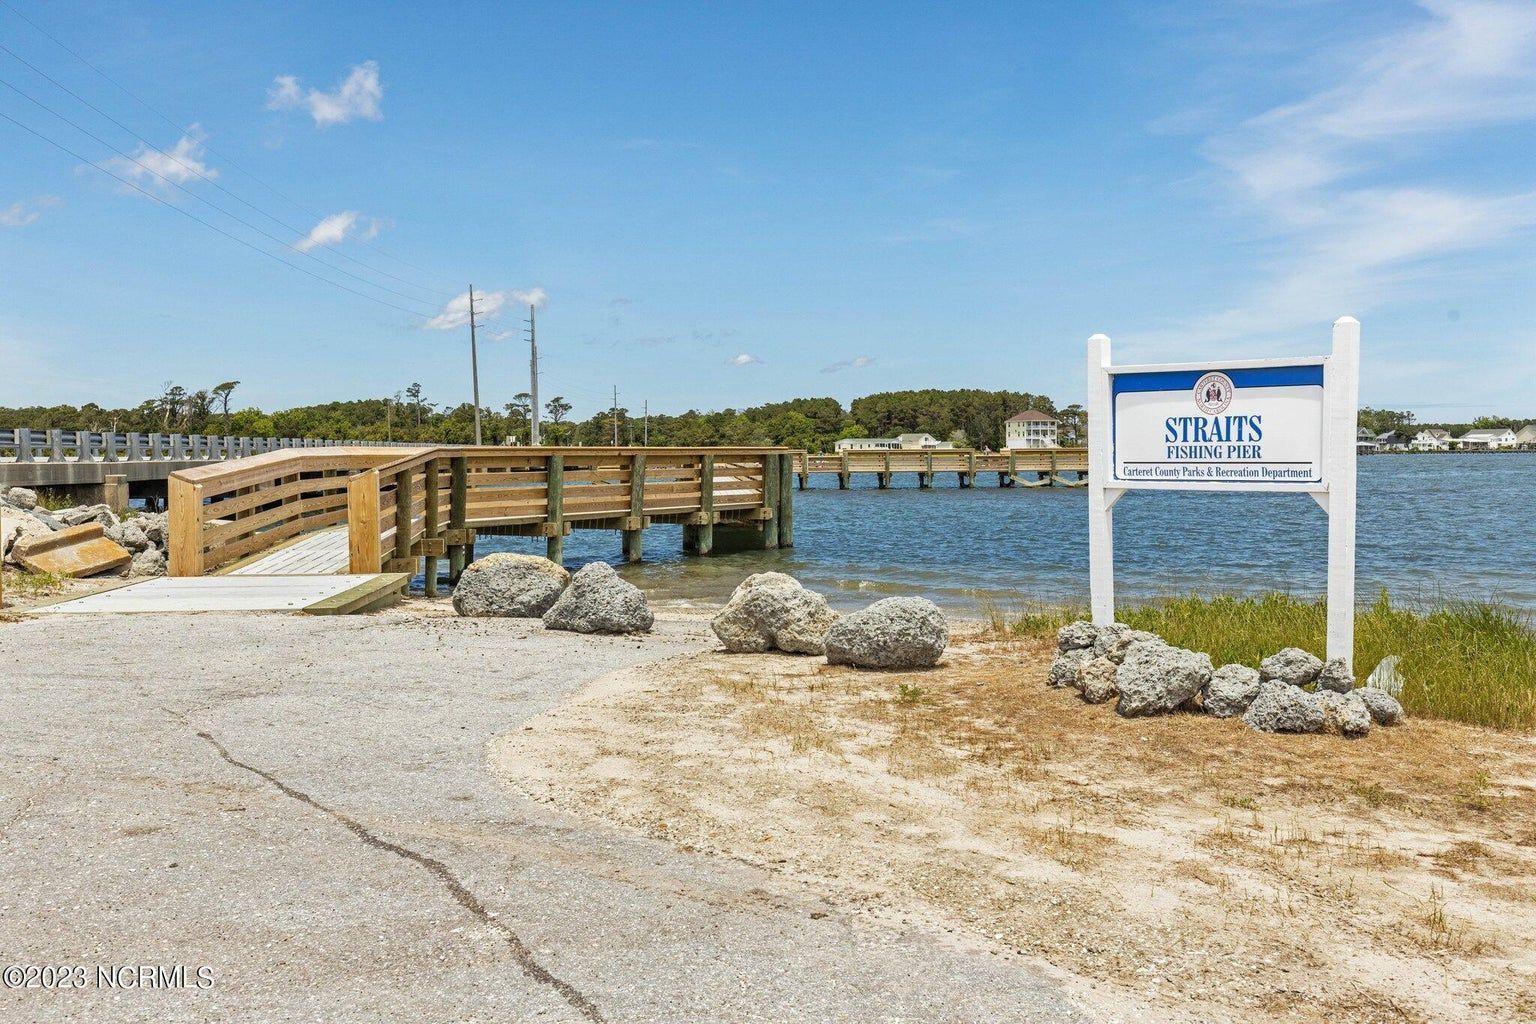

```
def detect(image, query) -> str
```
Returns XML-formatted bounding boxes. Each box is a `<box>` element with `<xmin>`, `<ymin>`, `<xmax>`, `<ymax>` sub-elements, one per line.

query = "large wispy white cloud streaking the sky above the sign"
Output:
<box><xmin>1132</xmin><ymin>0</ymin><xmax>1536</xmax><ymax>353</ymax></box>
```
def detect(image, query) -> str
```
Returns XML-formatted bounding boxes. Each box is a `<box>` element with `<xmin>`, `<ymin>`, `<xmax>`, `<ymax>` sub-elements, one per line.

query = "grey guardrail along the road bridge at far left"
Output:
<box><xmin>0</xmin><ymin>428</ymin><xmax>425</xmax><ymax>462</ymax></box>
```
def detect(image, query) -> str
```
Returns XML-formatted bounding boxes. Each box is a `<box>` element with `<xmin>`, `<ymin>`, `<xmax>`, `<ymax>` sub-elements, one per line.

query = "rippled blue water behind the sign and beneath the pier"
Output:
<box><xmin>476</xmin><ymin>453</ymin><xmax>1536</xmax><ymax>613</ymax></box>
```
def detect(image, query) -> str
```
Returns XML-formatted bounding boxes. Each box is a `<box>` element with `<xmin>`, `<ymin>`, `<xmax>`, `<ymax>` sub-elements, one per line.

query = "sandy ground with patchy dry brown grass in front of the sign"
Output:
<box><xmin>493</xmin><ymin>634</ymin><xmax>1536</xmax><ymax>1024</ymax></box>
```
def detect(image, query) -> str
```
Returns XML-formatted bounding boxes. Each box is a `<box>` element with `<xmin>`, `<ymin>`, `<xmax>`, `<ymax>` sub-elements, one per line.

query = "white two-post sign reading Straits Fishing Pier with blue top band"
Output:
<box><xmin>1087</xmin><ymin>316</ymin><xmax>1359</xmax><ymax>663</ymax></box>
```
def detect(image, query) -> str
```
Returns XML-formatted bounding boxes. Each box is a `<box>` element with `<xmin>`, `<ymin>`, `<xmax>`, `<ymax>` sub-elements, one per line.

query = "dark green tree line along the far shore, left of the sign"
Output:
<box><xmin>0</xmin><ymin>381</ymin><xmax>1086</xmax><ymax>451</ymax></box>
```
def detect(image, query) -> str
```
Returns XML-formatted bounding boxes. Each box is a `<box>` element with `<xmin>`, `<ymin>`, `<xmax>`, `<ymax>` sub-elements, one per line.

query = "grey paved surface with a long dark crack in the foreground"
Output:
<box><xmin>0</xmin><ymin>613</ymin><xmax>1084</xmax><ymax>1024</ymax></box>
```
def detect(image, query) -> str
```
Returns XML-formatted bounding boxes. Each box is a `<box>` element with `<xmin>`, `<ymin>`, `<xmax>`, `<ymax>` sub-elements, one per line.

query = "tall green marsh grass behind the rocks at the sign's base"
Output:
<box><xmin>989</xmin><ymin>593</ymin><xmax>1536</xmax><ymax>729</ymax></box>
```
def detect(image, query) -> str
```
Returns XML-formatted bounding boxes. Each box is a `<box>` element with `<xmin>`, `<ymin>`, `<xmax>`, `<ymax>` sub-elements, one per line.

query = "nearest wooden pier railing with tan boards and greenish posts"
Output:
<box><xmin>169</xmin><ymin>447</ymin><xmax>793</xmax><ymax>586</ymax></box>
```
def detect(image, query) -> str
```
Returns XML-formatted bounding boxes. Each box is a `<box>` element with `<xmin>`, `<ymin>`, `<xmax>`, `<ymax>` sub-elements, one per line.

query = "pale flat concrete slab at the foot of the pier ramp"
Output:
<box><xmin>32</xmin><ymin>574</ymin><xmax>399</xmax><ymax>616</ymax></box>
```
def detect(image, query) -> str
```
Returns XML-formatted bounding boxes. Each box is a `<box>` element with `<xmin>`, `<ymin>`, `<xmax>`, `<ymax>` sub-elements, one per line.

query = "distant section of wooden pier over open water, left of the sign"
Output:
<box><xmin>793</xmin><ymin>448</ymin><xmax>1087</xmax><ymax>491</ymax></box>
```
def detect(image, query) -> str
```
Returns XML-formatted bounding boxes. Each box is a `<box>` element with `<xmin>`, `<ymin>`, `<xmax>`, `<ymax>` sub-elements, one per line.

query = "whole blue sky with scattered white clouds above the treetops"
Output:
<box><xmin>0</xmin><ymin>0</ymin><xmax>1536</xmax><ymax>419</ymax></box>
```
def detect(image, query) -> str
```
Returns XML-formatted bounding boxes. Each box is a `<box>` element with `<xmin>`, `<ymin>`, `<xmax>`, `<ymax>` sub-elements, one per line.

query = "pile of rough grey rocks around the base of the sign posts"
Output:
<box><xmin>1046</xmin><ymin>622</ymin><xmax>1404</xmax><ymax>737</ymax></box>
